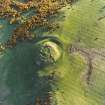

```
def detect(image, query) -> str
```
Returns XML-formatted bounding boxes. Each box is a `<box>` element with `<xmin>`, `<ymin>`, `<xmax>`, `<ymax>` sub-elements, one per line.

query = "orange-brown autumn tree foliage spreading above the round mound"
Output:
<box><xmin>0</xmin><ymin>0</ymin><xmax>71</xmax><ymax>48</ymax></box>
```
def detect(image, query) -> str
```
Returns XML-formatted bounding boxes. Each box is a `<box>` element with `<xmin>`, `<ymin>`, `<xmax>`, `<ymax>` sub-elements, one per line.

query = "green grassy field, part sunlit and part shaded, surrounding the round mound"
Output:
<box><xmin>0</xmin><ymin>0</ymin><xmax>105</xmax><ymax>105</ymax></box>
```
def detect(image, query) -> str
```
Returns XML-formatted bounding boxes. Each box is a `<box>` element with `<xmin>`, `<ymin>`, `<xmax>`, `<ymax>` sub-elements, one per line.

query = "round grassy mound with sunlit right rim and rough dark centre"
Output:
<box><xmin>35</xmin><ymin>40</ymin><xmax>61</xmax><ymax>66</ymax></box>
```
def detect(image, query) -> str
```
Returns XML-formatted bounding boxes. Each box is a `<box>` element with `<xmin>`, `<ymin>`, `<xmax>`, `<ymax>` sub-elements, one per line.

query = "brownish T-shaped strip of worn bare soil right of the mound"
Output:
<box><xmin>69</xmin><ymin>44</ymin><xmax>105</xmax><ymax>85</ymax></box>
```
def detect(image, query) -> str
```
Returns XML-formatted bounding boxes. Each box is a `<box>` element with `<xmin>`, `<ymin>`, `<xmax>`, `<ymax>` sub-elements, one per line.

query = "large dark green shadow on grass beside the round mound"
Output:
<box><xmin>1</xmin><ymin>43</ymin><xmax>50</xmax><ymax>105</ymax></box>
